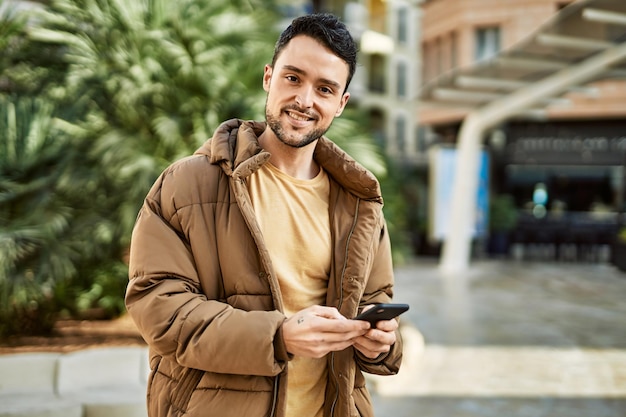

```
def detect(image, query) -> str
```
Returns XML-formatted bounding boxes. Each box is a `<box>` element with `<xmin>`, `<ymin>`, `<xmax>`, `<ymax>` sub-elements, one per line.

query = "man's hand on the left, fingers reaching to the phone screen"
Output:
<box><xmin>283</xmin><ymin>306</ymin><xmax>370</xmax><ymax>358</ymax></box>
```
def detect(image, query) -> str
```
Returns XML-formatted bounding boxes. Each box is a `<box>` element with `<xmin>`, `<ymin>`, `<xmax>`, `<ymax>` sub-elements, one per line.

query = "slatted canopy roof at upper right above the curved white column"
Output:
<box><xmin>419</xmin><ymin>0</ymin><xmax>626</xmax><ymax>120</ymax></box>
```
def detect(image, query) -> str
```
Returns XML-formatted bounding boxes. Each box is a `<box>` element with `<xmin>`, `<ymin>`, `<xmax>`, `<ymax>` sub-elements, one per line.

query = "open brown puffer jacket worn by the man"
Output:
<box><xmin>126</xmin><ymin>120</ymin><xmax>402</xmax><ymax>417</ymax></box>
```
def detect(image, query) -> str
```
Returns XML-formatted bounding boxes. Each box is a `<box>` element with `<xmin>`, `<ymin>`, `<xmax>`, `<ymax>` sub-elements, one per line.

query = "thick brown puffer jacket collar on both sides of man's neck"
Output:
<box><xmin>195</xmin><ymin>119</ymin><xmax>382</xmax><ymax>203</ymax></box>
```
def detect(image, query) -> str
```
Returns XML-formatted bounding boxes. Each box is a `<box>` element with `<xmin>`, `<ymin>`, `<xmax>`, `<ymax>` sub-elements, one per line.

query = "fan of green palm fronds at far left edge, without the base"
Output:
<box><xmin>0</xmin><ymin>96</ymin><xmax>67</xmax><ymax>270</ymax></box>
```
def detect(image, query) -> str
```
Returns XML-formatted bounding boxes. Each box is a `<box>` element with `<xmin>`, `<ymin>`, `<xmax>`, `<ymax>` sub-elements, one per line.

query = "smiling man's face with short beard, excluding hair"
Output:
<box><xmin>263</xmin><ymin>35</ymin><xmax>350</xmax><ymax>148</ymax></box>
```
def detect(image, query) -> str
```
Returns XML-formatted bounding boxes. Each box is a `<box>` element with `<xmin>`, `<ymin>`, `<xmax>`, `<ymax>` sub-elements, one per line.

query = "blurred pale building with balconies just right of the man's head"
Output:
<box><xmin>346</xmin><ymin>0</ymin><xmax>425</xmax><ymax>165</ymax></box>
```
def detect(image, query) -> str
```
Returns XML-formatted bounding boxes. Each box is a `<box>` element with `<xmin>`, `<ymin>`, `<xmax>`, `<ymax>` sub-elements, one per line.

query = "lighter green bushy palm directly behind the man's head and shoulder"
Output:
<box><xmin>30</xmin><ymin>0</ymin><xmax>276</xmax><ymax>239</ymax></box>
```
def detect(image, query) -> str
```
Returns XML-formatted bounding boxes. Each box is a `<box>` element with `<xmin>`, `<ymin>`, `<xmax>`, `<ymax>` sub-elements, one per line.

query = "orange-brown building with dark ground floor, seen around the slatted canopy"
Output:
<box><xmin>418</xmin><ymin>0</ymin><xmax>626</xmax><ymax>260</ymax></box>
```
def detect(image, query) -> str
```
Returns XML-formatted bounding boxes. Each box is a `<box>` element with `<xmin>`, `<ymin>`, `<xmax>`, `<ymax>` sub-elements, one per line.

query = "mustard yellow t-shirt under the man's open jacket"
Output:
<box><xmin>249</xmin><ymin>163</ymin><xmax>332</xmax><ymax>417</ymax></box>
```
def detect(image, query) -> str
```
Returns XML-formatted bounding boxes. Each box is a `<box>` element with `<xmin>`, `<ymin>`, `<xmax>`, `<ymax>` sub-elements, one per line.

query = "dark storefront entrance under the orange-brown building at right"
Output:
<box><xmin>490</xmin><ymin>120</ymin><xmax>626</xmax><ymax>261</ymax></box>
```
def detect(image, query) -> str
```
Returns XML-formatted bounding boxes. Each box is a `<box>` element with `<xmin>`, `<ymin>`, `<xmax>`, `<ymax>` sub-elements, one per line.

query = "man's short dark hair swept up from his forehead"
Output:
<box><xmin>272</xmin><ymin>13</ymin><xmax>358</xmax><ymax>89</ymax></box>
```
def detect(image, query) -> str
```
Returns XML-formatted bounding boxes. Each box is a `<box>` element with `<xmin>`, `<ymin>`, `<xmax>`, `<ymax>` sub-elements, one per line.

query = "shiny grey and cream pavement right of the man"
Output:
<box><xmin>369</xmin><ymin>258</ymin><xmax>626</xmax><ymax>417</ymax></box>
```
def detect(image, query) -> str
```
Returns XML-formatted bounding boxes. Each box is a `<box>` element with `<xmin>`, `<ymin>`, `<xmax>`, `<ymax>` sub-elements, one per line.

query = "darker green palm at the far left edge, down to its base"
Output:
<box><xmin>0</xmin><ymin>96</ymin><xmax>78</xmax><ymax>334</ymax></box>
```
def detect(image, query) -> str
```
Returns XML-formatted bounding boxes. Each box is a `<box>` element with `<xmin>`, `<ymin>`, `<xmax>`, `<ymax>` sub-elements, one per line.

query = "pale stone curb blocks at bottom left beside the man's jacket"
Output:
<box><xmin>0</xmin><ymin>347</ymin><xmax>149</xmax><ymax>417</ymax></box>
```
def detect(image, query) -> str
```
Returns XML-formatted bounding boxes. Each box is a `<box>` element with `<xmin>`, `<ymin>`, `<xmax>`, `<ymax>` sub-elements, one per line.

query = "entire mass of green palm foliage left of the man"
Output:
<box><xmin>0</xmin><ymin>0</ymin><xmax>284</xmax><ymax>334</ymax></box>
